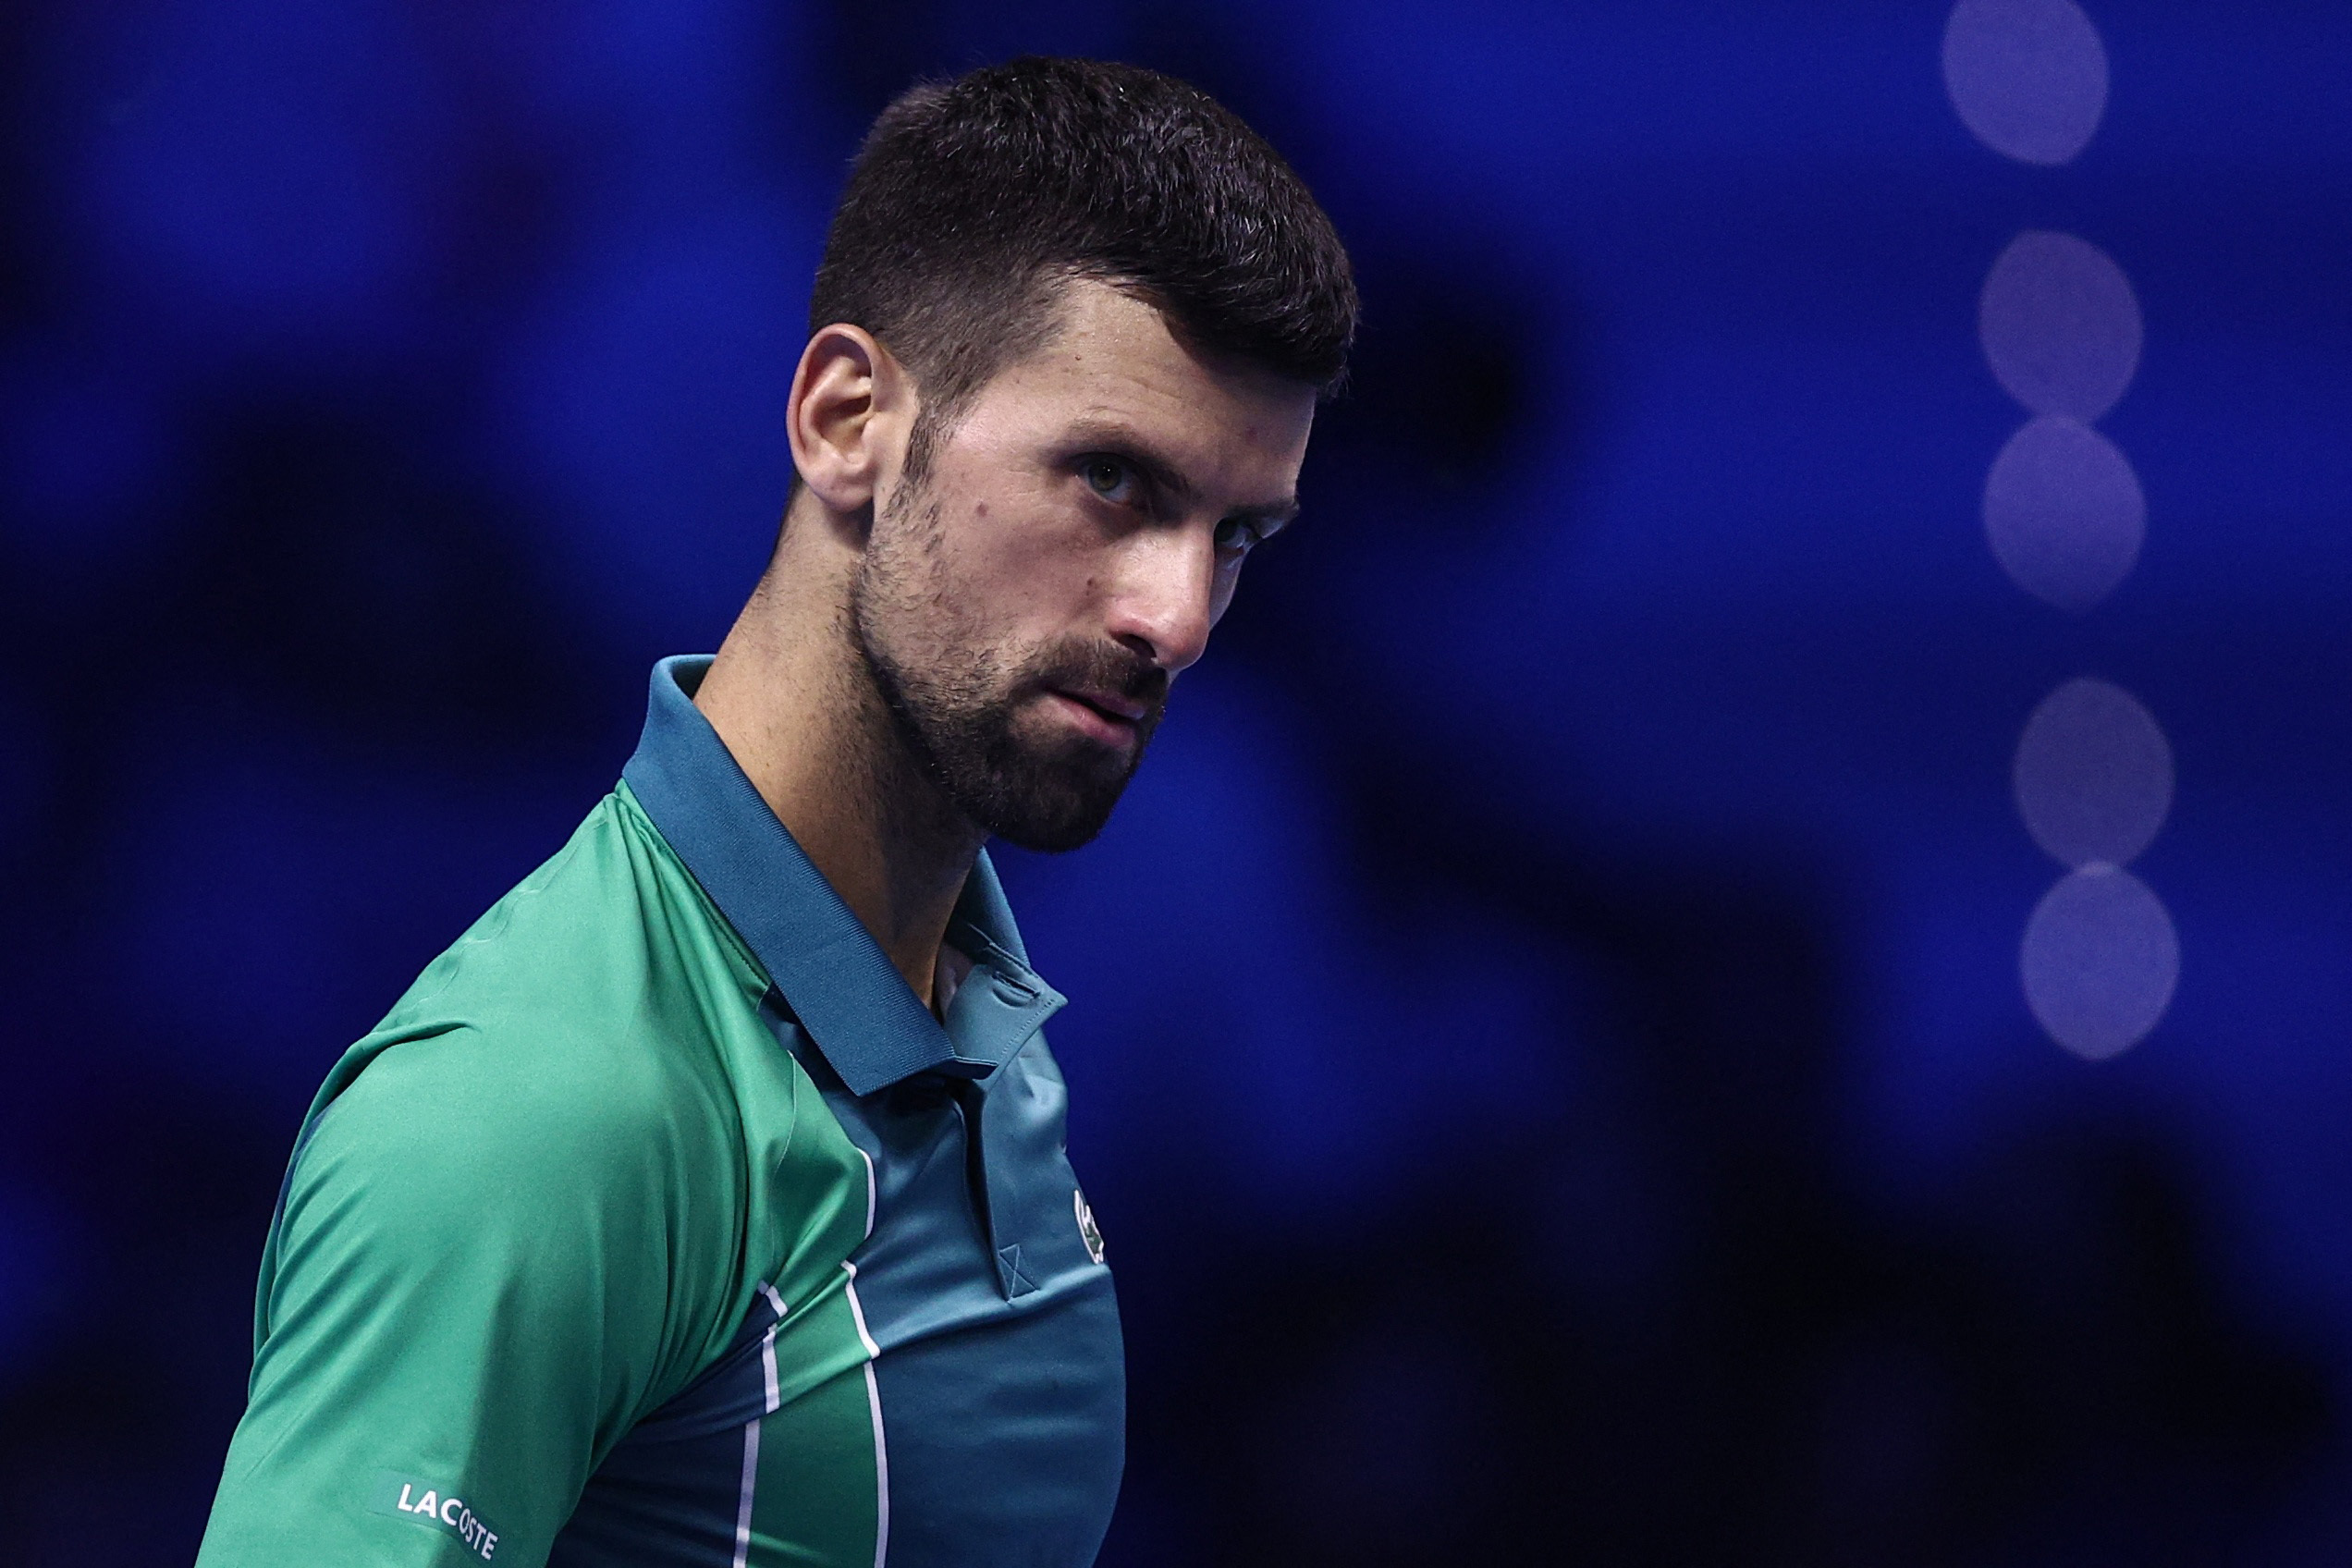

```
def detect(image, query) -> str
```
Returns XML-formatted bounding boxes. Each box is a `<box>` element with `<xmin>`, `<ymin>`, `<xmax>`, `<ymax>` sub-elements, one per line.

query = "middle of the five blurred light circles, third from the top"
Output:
<box><xmin>1985</xmin><ymin>419</ymin><xmax>2148</xmax><ymax>611</ymax></box>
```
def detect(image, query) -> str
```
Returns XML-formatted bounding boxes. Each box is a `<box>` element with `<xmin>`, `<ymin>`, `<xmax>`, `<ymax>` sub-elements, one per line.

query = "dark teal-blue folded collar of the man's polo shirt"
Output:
<box><xmin>621</xmin><ymin>654</ymin><xmax>1063</xmax><ymax>1096</ymax></box>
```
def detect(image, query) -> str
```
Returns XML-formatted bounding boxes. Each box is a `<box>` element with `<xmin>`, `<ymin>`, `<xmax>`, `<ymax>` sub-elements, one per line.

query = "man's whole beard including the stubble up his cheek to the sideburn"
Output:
<box><xmin>849</xmin><ymin>484</ymin><xmax>1169</xmax><ymax>851</ymax></box>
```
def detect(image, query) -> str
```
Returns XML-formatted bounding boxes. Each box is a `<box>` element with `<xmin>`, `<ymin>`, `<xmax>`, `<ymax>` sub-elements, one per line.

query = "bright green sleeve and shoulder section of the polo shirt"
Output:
<box><xmin>198</xmin><ymin>788</ymin><xmax>868</xmax><ymax>1568</ymax></box>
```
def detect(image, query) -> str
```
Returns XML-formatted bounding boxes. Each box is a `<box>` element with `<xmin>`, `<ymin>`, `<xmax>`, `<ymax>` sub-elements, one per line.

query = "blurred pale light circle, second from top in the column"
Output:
<box><xmin>1976</xmin><ymin>228</ymin><xmax>2140</xmax><ymax>423</ymax></box>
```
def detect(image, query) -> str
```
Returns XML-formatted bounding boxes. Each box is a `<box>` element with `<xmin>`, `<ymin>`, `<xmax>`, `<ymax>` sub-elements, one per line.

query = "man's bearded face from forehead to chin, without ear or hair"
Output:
<box><xmin>851</xmin><ymin>280</ymin><xmax>1315</xmax><ymax>849</ymax></box>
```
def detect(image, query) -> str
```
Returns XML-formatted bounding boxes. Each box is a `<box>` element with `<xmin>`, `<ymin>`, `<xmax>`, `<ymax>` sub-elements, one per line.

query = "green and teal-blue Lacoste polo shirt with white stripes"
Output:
<box><xmin>200</xmin><ymin>661</ymin><xmax>1124</xmax><ymax>1568</ymax></box>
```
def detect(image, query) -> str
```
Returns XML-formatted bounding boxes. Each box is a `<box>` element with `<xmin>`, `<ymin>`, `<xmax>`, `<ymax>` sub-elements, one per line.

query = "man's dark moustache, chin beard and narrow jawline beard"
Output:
<box><xmin>849</xmin><ymin>520</ymin><xmax>1169</xmax><ymax>853</ymax></box>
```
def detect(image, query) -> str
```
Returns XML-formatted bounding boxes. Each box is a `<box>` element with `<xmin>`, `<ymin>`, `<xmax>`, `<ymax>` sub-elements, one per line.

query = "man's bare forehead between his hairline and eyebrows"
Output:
<box><xmin>957</xmin><ymin>277</ymin><xmax>1315</xmax><ymax>486</ymax></box>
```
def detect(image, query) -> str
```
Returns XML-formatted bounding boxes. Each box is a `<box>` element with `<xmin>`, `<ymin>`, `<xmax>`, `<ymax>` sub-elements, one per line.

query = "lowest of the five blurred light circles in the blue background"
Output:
<box><xmin>2018</xmin><ymin>865</ymin><xmax>2180</xmax><ymax>1062</ymax></box>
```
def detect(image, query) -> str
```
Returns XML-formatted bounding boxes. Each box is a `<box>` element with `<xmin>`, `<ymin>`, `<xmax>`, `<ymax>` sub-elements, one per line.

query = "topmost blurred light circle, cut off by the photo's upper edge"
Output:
<box><xmin>1942</xmin><ymin>0</ymin><xmax>2107</xmax><ymax>165</ymax></box>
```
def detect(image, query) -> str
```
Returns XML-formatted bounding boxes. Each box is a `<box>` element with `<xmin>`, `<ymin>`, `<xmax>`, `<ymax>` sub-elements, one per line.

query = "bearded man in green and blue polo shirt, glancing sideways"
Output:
<box><xmin>202</xmin><ymin>59</ymin><xmax>1354</xmax><ymax>1568</ymax></box>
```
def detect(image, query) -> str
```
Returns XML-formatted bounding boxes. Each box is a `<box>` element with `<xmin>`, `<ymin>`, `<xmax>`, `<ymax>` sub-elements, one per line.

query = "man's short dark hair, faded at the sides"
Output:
<box><xmin>809</xmin><ymin>56</ymin><xmax>1357</xmax><ymax>471</ymax></box>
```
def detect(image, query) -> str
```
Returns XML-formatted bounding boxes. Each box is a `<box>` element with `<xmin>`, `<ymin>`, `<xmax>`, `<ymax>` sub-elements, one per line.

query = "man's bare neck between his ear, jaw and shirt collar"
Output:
<box><xmin>693</xmin><ymin>489</ymin><xmax>986</xmax><ymax>1006</ymax></box>
